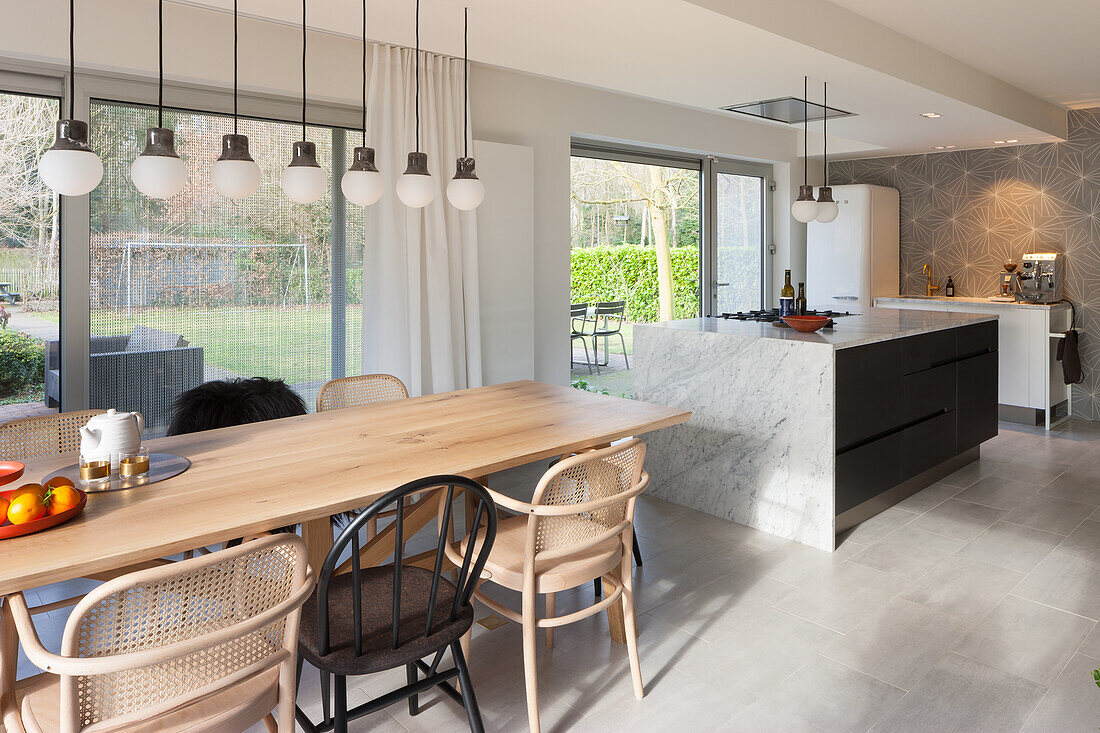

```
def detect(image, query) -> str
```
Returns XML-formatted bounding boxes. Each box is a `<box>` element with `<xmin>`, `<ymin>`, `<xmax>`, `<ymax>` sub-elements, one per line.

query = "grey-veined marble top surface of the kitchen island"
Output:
<box><xmin>635</xmin><ymin>308</ymin><xmax>997</xmax><ymax>349</ymax></box>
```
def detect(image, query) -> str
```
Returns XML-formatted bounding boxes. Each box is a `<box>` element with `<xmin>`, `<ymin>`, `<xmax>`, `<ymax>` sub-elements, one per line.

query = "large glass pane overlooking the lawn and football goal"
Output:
<box><xmin>89</xmin><ymin>100</ymin><xmax>363</xmax><ymax>434</ymax></box>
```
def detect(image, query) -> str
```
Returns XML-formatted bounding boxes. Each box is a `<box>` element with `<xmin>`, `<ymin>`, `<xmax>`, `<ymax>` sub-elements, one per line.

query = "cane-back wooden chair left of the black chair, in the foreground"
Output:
<box><xmin>8</xmin><ymin>535</ymin><xmax>314</xmax><ymax>733</ymax></box>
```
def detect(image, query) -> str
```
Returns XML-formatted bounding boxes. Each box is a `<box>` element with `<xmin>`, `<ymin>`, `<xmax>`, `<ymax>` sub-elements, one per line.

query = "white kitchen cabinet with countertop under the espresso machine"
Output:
<box><xmin>875</xmin><ymin>296</ymin><xmax>1071</xmax><ymax>428</ymax></box>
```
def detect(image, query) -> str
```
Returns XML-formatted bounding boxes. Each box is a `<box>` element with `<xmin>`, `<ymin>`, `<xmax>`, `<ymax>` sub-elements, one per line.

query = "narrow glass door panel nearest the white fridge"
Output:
<box><xmin>708</xmin><ymin>161</ymin><xmax>771</xmax><ymax>316</ymax></box>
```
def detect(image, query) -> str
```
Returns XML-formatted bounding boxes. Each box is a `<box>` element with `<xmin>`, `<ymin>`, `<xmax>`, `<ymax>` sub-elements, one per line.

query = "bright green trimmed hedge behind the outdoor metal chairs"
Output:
<box><xmin>570</xmin><ymin>243</ymin><xmax>699</xmax><ymax>324</ymax></box>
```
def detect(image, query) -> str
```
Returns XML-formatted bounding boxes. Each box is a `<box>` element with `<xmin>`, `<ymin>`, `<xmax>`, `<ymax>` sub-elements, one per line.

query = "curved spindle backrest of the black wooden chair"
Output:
<box><xmin>317</xmin><ymin>475</ymin><xmax>496</xmax><ymax>656</ymax></box>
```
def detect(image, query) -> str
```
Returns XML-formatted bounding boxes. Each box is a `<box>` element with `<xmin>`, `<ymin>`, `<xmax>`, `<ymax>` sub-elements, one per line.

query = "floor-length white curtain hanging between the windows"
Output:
<box><xmin>353</xmin><ymin>44</ymin><xmax>482</xmax><ymax>395</ymax></box>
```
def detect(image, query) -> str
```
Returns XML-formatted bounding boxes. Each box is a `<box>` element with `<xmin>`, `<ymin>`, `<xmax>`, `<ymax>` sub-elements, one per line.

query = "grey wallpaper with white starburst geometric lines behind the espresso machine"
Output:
<box><xmin>829</xmin><ymin>108</ymin><xmax>1100</xmax><ymax>419</ymax></box>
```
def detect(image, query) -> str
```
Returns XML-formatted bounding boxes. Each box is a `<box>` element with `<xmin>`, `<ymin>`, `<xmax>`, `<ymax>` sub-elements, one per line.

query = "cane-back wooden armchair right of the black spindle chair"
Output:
<box><xmin>451</xmin><ymin>439</ymin><xmax>649</xmax><ymax>733</ymax></box>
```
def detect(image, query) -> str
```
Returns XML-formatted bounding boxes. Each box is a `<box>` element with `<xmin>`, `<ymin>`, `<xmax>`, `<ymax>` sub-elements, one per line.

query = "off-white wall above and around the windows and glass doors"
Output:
<box><xmin>0</xmin><ymin>0</ymin><xmax>820</xmax><ymax>384</ymax></box>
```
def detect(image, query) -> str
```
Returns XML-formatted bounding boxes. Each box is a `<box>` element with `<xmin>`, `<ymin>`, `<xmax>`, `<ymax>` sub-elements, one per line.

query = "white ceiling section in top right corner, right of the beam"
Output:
<box><xmin>831</xmin><ymin>0</ymin><xmax>1100</xmax><ymax>108</ymax></box>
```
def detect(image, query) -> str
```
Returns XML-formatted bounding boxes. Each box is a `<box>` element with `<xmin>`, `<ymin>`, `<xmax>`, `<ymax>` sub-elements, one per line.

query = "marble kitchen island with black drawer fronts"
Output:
<box><xmin>634</xmin><ymin>308</ymin><xmax>997</xmax><ymax>550</ymax></box>
